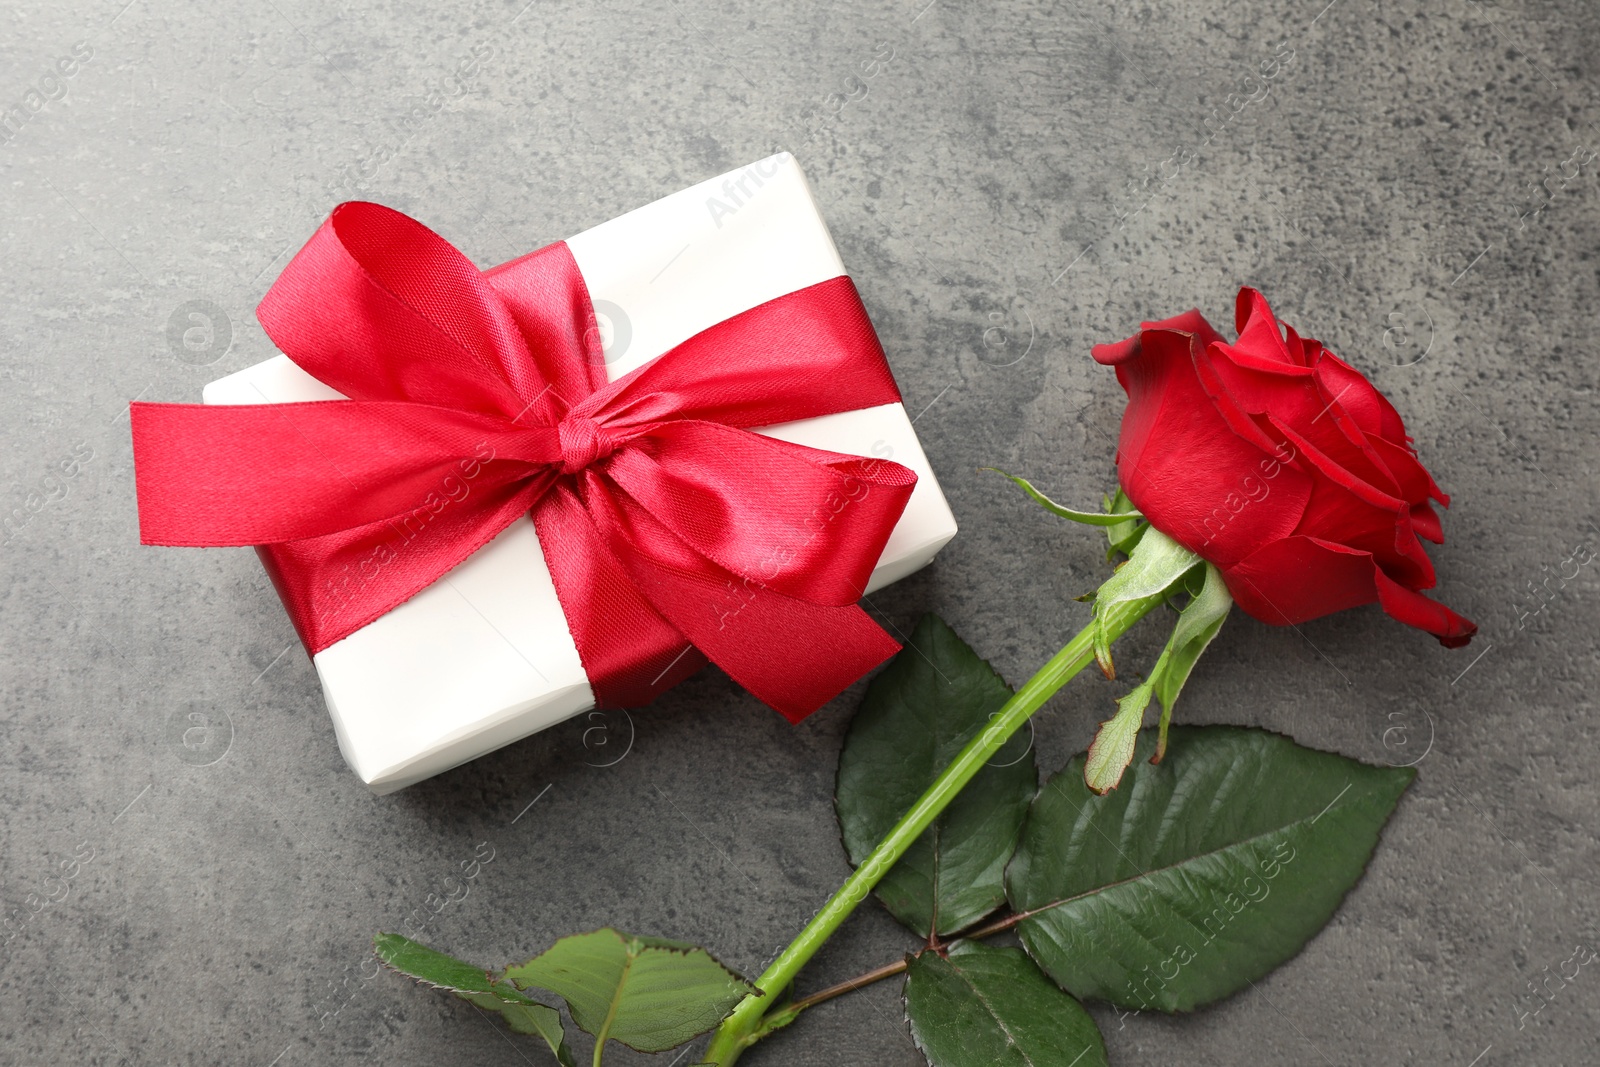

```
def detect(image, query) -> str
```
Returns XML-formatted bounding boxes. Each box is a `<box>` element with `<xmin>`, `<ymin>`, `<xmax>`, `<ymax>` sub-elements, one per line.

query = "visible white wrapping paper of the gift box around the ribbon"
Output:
<box><xmin>205</xmin><ymin>152</ymin><xmax>955</xmax><ymax>793</ymax></box>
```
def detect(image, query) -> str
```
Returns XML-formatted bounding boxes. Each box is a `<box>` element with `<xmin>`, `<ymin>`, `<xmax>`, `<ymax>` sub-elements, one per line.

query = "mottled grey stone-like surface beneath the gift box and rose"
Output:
<box><xmin>0</xmin><ymin>0</ymin><xmax>1600</xmax><ymax>1067</ymax></box>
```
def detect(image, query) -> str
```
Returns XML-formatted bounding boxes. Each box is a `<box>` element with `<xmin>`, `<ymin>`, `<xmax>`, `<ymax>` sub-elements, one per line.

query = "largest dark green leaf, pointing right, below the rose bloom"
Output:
<box><xmin>1006</xmin><ymin>726</ymin><xmax>1416</xmax><ymax>1011</ymax></box>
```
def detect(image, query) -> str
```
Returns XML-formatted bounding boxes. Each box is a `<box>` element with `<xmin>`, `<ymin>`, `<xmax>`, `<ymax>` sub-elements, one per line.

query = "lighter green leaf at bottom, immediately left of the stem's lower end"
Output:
<box><xmin>506</xmin><ymin>929</ymin><xmax>755</xmax><ymax>1053</ymax></box>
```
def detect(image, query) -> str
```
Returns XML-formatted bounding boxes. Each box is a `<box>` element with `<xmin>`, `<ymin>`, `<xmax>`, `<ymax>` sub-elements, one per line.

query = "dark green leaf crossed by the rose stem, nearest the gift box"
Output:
<box><xmin>834</xmin><ymin>614</ymin><xmax>1038</xmax><ymax>937</ymax></box>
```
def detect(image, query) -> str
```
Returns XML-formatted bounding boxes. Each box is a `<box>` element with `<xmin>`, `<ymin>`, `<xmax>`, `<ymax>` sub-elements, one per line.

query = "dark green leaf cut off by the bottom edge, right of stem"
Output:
<box><xmin>906</xmin><ymin>941</ymin><xmax>1106</xmax><ymax>1067</ymax></box>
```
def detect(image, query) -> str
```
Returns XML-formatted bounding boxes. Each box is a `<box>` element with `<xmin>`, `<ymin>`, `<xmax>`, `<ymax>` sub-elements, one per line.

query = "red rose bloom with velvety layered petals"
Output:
<box><xmin>1094</xmin><ymin>288</ymin><xmax>1478</xmax><ymax>648</ymax></box>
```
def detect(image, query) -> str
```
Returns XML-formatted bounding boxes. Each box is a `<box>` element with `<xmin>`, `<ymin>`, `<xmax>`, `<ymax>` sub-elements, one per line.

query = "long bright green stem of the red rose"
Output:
<box><xmin>704</xmin><ymin>592</ymin><xmax>1166</xmax><ymax>1067</ymax></box>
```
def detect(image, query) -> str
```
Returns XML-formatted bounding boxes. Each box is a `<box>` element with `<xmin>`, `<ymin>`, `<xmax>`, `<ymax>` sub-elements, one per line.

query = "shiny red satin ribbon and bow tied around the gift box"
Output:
<box><xmin>133</xmin><ymin>203</ymin><xmax>917</xmax><ymax>721</ymax></box>
